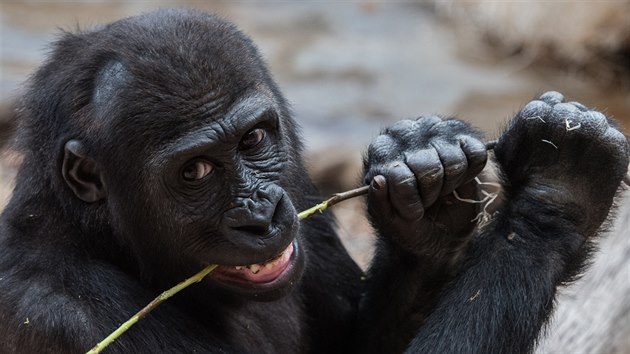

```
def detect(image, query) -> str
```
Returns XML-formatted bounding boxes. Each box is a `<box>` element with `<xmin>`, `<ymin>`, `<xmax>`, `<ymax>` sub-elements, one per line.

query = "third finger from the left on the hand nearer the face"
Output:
<box><xmin>431</xmin><ymin>141</ymin><xmax>468</xmax><ymax>196</ymax></box>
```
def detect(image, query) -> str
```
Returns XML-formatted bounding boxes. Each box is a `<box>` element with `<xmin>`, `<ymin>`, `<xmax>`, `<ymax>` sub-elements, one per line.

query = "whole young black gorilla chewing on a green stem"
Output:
<box><xmin>0</xmin><ymin>10</ymin><xmax>628</xmax><ymax>353</ymax></box>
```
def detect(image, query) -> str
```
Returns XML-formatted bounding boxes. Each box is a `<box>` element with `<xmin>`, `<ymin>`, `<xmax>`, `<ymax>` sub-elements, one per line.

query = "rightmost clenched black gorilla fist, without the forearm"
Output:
<box><xmin>495</xmin><ymin>92</ymin><xmax>630</xmax><ymax>236</ymax></box>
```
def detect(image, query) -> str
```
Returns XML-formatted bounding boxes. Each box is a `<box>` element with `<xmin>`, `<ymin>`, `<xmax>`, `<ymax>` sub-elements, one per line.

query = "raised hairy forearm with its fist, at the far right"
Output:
<box><xmin>408</xmin><ymin>92</ymin><xmax>629</xmax><ymax>353</ymax></box>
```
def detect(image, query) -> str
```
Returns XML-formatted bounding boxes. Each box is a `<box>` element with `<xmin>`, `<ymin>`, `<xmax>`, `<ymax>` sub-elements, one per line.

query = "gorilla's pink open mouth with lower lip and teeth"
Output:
<box><xmin>215</xmin><ymin>242</ymin><xmax>294</xmax><ymax>284</ymax></box>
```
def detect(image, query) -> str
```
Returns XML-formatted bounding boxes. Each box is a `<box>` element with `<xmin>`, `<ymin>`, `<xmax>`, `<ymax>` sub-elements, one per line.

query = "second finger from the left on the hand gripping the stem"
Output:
<box><xmin>406</xmin><ymin>148</ymin><xmax>444</xmax><ymax>209</ymax></box>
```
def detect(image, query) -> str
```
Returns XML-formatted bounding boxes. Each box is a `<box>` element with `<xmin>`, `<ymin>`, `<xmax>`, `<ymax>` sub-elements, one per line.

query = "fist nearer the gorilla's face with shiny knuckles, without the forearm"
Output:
<box><xmin>364</xmin><ymin>116</ymin><xmax>487</xmax><ymax>263</ymax></box>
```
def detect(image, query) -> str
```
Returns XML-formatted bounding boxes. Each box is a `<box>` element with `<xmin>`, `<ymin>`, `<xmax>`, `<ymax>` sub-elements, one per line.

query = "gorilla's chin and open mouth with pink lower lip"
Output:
<box><xmin>208</xmin><ymin>238</ymin><xmax>305</xmax><ymax>301</ymax></box>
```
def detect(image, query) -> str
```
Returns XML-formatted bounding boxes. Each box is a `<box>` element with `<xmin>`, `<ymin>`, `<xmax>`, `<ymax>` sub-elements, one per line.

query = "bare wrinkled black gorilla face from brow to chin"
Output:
<box><xmin>136</xmin><ymin>94</ymin><xmax>304</xmax><ymax>298</ymax></box>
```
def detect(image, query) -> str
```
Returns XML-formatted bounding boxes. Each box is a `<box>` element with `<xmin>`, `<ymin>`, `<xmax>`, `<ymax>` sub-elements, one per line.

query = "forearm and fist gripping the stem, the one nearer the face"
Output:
<box><xmin>357</xmin><ymin>117</ymin><xmax>486</xmax><ymax>353</ymax></box>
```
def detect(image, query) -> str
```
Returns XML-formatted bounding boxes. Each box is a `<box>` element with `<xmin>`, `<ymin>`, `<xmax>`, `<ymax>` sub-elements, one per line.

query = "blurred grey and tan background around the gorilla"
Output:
<box><xmin>0</xmin><ymin>0</ymin><xmax>630</xmax><ymax>353</ymax></box>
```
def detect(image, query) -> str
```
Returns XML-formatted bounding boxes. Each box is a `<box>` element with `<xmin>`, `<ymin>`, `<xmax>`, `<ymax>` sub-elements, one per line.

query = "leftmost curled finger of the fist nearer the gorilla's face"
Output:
<box><xmin>387</xmin><ymin>161</ymin><xmax>424</xmax><ymax>220</ymax></box>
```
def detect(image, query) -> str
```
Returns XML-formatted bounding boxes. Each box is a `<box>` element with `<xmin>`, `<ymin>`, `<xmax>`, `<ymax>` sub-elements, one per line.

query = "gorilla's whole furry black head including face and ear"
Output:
<box><xmin>21</xmin><ymin>11</ymin><xmax>310</xmax><ymax>299</ymax></box>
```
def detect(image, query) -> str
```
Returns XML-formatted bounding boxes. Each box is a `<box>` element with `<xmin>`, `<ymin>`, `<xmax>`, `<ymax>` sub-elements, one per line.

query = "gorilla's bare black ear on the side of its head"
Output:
<box><xmin>61</xmin><ymin>140</ymin><xmax>105</xmax><ymax>203</ymax></box>
